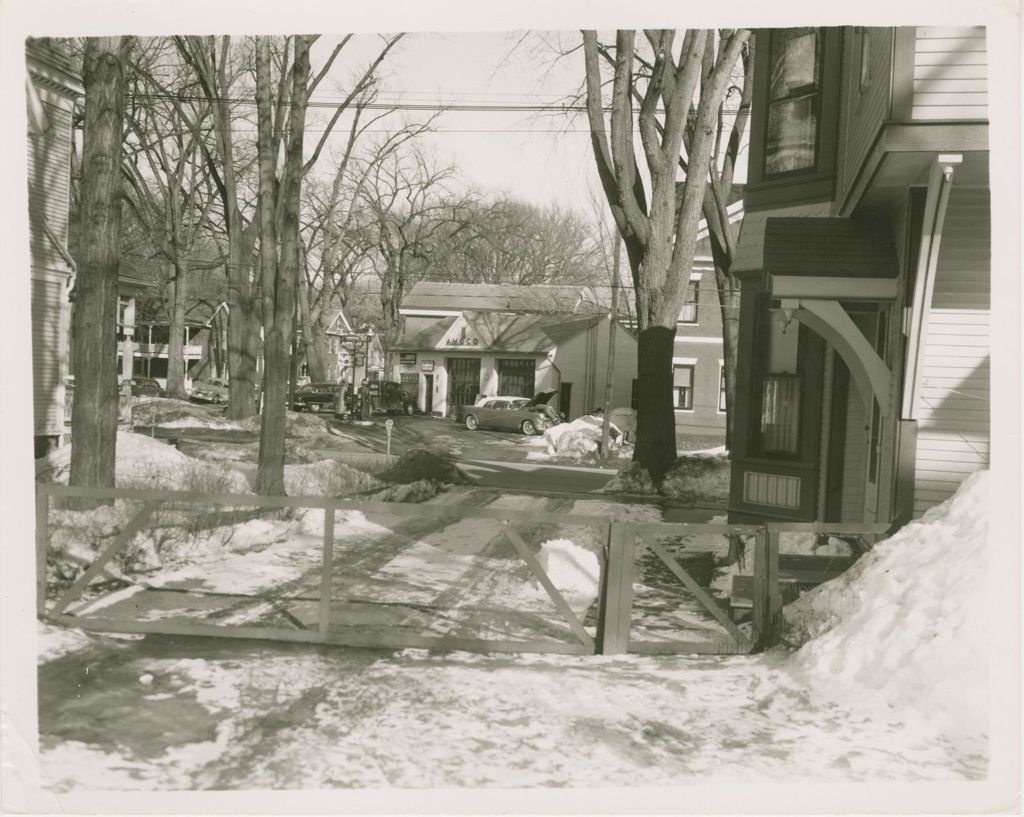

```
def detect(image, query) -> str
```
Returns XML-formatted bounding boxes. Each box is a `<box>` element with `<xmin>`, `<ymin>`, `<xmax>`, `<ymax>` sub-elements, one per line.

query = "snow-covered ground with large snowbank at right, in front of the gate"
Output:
<box><xmin>29</xmin><ymin>435</ymin><xmax>989</xmax><ymax>791</ymax></box>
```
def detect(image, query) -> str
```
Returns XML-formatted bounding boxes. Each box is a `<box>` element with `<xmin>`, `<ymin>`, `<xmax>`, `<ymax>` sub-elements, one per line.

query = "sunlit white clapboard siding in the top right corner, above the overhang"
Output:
<box><xmin>910</xmin><ymin>26</ymin><xmax>988</xmax><ymax>120</ymax></box>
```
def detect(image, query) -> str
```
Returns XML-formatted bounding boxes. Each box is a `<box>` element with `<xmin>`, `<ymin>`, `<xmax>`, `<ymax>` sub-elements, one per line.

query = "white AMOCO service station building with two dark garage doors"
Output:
<box><xmin>391</xmin><ymin>282</ymin><xmax>637</xmax><ymax>420</ymax></box>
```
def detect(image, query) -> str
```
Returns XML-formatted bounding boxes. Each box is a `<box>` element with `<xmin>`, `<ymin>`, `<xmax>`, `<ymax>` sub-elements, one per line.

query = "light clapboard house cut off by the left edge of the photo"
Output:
<box><xmin>26</xmin><ymin>39</ymin><xmax>83</xmax><ymax>456</ymax></box>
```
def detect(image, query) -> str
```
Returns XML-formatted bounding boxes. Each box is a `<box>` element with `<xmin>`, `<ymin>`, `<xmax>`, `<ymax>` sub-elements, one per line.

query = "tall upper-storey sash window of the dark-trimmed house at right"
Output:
<box><xmin>765</xmin><ymin>29</ymin><xmax>821</xmax><ymax>176</ymax></box>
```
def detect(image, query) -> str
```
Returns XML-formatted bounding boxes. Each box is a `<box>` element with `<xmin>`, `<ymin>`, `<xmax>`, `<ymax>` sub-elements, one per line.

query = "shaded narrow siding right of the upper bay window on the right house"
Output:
<box><xmin>837</xmin><ymin>28</ymin><xmax>894</xmax><ymax>209</ymax></box>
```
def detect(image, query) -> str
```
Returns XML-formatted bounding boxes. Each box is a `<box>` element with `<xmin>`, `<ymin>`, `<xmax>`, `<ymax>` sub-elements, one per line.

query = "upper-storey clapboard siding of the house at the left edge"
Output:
<box><xmin>28</xmin><ymin>90</ymin><xmax>72</xmax><ymax>269</ymax></box>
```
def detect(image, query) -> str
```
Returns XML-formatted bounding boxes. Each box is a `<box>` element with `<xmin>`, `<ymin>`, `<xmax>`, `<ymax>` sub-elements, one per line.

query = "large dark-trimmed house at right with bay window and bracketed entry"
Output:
<box><xmin>730</xmin><ymin>27</ymin><xmax>990</xmax><ymax>523</ymax></box>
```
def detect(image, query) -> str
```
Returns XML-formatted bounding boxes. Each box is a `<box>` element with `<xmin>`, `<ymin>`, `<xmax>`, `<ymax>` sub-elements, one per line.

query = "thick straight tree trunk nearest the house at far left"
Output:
<box><xmin>70</xmin><ymin>37</ymin><xmax>131</xmax><ymax>499</ymax></box>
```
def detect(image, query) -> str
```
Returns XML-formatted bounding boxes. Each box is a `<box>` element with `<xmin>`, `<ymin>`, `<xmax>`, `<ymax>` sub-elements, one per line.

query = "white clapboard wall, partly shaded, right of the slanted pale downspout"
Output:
<box><xmin>914</xmin><ymin>188</ymin><xmax>990</xmax><ymax>515</ymax></box>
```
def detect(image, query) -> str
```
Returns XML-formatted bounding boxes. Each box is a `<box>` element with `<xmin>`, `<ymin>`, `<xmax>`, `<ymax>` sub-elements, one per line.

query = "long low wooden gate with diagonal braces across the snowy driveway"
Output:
<box><xmin>36</xmin><ymin>483</ymin><xmax>886</xmax><ymax>655</ymax></box>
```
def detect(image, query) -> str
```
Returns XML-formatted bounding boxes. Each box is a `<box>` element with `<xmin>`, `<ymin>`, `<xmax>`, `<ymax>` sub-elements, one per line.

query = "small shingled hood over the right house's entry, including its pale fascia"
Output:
<box><xmin>764</xmin><ymin>218</ymin><xmax>899</xmax><ymax>301</ymax></box>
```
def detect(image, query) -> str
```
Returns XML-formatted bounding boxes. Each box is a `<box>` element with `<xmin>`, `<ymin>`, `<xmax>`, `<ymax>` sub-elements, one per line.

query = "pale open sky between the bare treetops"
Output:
<box><xmin>303</xmin><ymin>31</ymin><xmax>744</xmax><ymax>218</ymax></box>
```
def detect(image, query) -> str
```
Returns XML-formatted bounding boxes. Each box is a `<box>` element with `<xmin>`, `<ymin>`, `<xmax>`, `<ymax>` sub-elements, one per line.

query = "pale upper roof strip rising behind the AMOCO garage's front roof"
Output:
<box><xmin>401</xmin><ymin>281</ymin><xmax>581</xmax><ymax>314</ymax></box>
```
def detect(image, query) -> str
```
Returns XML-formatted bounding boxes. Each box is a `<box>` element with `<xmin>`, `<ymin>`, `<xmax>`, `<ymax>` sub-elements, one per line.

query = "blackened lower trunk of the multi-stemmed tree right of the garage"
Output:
<box><xmin>633</xmin><ymin>326</ymin><xmax>676</xmax><ymax>483</ymax></box>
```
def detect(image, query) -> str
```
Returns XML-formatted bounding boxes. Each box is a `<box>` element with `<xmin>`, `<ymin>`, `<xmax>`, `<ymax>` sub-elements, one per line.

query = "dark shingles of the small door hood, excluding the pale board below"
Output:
<box><xmin>764</xmin><ymin>217</ymin><xmax>899</xmax><ymax>278</ymax></box>
